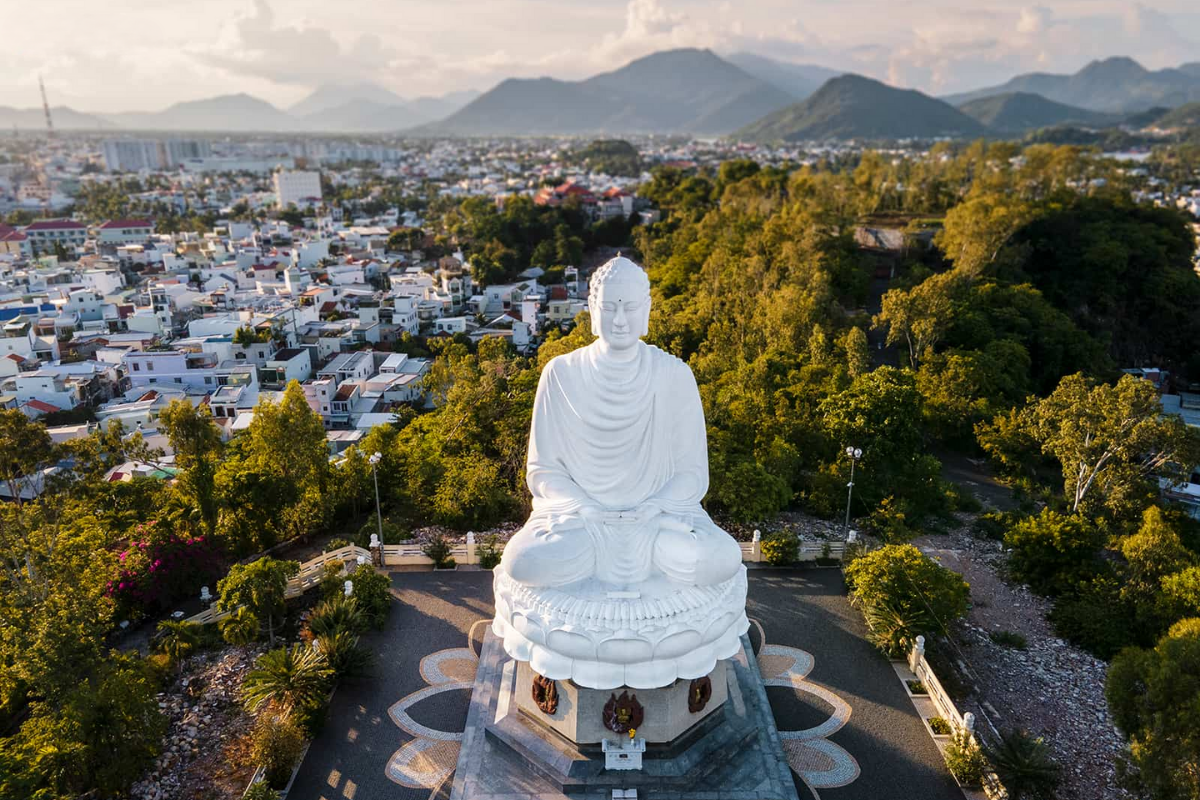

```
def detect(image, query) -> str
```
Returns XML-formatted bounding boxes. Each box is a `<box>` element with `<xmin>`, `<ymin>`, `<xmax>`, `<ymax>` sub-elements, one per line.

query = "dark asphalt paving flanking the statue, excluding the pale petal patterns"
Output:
<box><xmin>289</xmin><ymin>570</ymin><xmax>962</xmax><ymax>800</ymax></box>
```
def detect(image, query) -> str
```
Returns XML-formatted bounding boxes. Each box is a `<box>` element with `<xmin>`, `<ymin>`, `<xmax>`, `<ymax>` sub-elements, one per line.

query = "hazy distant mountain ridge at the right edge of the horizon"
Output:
<box><xmin>942</xmin><ymin>56</ymin><xmax>1200</xmax><ymax>113</ymax></box>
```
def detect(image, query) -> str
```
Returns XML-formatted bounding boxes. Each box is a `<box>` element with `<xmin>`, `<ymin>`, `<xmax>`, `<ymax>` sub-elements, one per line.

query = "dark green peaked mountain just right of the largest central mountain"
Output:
<box><xmin>733</xmin><ymin>74</ymin><xmax>986</xmax><ymax>142</ymax></box>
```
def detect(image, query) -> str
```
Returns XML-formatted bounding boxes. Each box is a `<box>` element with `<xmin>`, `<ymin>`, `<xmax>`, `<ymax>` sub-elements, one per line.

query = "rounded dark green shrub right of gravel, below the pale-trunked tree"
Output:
<box><xmin>1004</xmin><ymin>509</ymin><xmax>1104</xmax><ymax>595</ymax></box>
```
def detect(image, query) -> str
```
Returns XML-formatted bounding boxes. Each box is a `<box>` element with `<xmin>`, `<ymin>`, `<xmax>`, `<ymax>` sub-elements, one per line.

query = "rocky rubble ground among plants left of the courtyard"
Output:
<box><xmin>130</xmin><ymin>645</ymin><xmax>264</xmax><ymax>800</ymax></box>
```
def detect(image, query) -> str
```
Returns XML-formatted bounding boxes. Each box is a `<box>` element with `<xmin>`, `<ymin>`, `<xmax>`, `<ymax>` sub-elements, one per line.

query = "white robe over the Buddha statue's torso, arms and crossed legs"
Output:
<box><xmin>502</xmin><ymin>342</ymin><xmax>742</xmax><ymax>585</ymax></box>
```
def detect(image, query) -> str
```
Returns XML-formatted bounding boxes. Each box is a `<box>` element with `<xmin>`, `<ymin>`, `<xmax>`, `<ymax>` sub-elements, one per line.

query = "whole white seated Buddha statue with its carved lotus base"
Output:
<box><xmin>493</xmin><ymin>257</ymin><xmax>748</xmax><ymax>687</ymax></box>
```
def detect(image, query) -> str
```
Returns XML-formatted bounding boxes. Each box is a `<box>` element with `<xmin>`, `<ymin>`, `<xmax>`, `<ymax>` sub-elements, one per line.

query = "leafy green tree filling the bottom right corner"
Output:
<box><xmin>1105</xmin><ymin>618</ymin><xmax>1200</xmax><ymax>800</ymax></box>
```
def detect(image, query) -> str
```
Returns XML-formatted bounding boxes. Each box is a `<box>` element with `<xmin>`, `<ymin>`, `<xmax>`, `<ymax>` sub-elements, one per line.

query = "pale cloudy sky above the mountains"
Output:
<box><xmin>0</xmin><ymin>0</ymin><xmax>1200</xmax><ymax>112</ymax></box>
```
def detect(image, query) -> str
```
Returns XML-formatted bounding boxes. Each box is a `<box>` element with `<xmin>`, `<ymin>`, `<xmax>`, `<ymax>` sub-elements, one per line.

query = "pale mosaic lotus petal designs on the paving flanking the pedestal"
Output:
<box><xmin>386</xmin><ymin>620</ymin><xmax>859</xmax><ymax>800</ymax></box>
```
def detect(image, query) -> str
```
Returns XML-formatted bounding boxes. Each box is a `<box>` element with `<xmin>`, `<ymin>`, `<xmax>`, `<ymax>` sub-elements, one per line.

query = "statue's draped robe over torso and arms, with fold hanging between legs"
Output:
<box><xmin>526</xmin><ymin>342</ymin><xmax>718</xmax><ymax>579</ymax></box>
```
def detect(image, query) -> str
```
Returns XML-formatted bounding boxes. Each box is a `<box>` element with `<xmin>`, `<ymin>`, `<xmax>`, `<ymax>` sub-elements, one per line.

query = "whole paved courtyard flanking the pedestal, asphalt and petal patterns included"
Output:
<box><xmin>288</xmin><ymin>570</ymin><xmax>962</xmax><ymax>800</ymax></box>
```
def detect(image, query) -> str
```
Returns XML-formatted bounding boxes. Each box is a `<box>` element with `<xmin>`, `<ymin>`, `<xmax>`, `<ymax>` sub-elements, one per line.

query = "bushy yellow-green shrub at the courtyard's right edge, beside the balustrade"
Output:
<box><xmin>845</xmin><ymin>545</ymin><xmax>971</xmax><ymax>655</ymax></box>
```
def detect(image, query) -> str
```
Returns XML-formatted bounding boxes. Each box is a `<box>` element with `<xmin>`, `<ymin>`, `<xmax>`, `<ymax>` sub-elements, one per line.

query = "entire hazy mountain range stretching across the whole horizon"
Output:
<box><xmin>0</xmin><ymin>48</ymin><xmax>1200</xmax><ymax>142</ymax></box>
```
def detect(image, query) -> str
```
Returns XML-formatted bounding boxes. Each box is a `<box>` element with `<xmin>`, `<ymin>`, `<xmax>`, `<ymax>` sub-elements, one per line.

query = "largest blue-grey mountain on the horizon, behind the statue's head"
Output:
<box><xmin>414</xmin><ymin>48</ymin><xmax>793</xmax><ymax>136</ymax></box>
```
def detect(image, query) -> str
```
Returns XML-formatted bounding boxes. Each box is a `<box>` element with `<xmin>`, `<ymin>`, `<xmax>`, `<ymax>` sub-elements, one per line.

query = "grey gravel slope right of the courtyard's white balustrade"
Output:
<box><xmin>913</xmin><ymin>529</ymin><xmax>1130</xmax><ymax>800</ymax></box>
